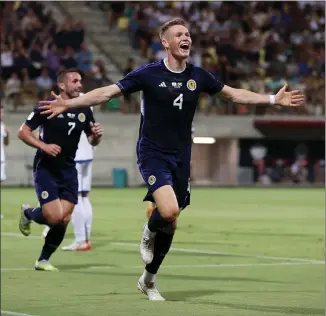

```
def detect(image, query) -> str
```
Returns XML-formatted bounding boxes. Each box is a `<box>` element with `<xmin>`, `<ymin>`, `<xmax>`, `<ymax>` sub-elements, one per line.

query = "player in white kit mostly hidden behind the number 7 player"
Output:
<box><xmin>62</xmin><ymin>105</ymin><xmax>94</xmax><ymax>251</ymax></box>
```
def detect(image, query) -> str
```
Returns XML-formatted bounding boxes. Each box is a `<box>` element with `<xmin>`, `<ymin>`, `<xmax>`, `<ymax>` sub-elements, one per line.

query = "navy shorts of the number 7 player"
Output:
<box><xmin>34</xmin><ymin>168</ymin><xmax>78</xmax><ymax>206</ymax></box>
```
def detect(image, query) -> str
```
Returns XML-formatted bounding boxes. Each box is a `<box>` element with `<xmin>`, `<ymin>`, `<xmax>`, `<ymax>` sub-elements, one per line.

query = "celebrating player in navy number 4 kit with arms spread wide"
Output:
<box><xmin>41</xmin><ymin>19</ymin><xmax>304</xmax><ymax>300</ymax></box>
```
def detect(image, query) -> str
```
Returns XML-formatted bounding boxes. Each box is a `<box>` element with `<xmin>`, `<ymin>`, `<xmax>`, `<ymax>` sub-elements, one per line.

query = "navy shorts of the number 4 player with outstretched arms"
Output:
<box><xmin>138</xmin><ymin>152</ymin><xmax>190</xmax><ymax>209</ymax></box>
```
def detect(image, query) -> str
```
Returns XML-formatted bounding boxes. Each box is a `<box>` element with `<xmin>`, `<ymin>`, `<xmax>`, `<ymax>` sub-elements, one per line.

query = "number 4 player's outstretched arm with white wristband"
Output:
<box><xmin>220</xmin><ymin>84</ymin><xmax>305</xmax><ymax>106</ymax></box>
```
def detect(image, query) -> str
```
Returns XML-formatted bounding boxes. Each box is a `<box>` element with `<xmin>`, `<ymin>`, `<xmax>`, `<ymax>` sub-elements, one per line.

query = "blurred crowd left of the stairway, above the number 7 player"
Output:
<box><xmin>0</xmin><ymin>1</ymin><xmax>106</xmax><ymax>111</ymax></box>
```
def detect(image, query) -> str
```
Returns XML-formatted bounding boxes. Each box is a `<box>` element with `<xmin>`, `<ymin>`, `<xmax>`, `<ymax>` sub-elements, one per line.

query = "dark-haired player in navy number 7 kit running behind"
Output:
<box><xmin>18</xmin><ymin>69</ymin><xmax>102</xmax><ymax>271</ymax></box>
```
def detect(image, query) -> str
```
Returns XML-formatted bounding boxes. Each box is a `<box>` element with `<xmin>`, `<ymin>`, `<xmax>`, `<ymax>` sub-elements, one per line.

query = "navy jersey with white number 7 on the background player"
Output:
<box><xmin>25</xmin><ymin>101</ymin><xmax>95</xmax><ymax>174</ymax></box>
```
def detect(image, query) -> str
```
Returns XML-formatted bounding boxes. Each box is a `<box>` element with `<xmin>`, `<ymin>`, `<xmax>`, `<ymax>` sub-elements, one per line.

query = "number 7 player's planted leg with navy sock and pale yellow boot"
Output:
<box><xmin>35</xmin><ymin>199</ymin><xmax>75</xmax><ymax>271</ymax></box>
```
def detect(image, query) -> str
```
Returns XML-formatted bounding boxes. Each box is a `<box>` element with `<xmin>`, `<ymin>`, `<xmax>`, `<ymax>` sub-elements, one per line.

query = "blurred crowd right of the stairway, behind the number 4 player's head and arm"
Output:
<box><xmin>94</xmin><ymin>1</ymin><xmax>325</xmax><ymax>115</ymax></box>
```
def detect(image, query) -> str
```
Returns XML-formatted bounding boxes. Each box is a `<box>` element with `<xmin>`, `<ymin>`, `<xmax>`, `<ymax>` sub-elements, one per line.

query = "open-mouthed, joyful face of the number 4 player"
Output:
<box><xmin>162</xmin><ymin>25</ymin><xmax>192</xmax><ymax>59</ymax></box>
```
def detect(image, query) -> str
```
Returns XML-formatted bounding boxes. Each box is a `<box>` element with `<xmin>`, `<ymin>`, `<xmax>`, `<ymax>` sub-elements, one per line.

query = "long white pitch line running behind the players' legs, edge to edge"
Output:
<box><xmin>1</xmin><ymin>232</ymin><xmax>325</xmax><ymax>264</ymax></box>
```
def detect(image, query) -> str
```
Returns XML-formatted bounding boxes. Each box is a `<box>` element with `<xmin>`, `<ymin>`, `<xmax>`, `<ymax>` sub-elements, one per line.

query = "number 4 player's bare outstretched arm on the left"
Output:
<box><xmin>40</xmin><ymin>84</ymin><xmax>121</xmax><ymax>119</ymax></box>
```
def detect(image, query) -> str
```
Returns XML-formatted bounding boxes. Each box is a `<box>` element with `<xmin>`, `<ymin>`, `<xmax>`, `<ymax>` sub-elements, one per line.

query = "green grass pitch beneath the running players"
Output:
<box><xmin>1</xmin><ymin>189</ymin><xmax>324</xmax><ymax>316</ymax></box>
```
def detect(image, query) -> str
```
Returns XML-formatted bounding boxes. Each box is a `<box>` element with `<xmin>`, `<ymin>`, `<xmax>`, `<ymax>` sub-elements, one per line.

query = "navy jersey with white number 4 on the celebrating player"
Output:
<box><xmin>117</xmin><ymin>60</ymin><xmax>224</xmax><ymax>153</ymax></box>
